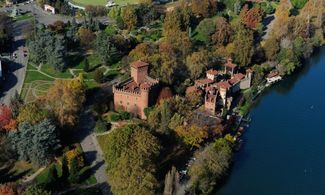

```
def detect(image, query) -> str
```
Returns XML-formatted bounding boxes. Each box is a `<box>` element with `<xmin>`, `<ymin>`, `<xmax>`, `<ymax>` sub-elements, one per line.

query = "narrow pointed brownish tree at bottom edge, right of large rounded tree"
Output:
<box><xmin>164</xmin><ymin>166</ymin><xmax>185</xmax><ymax>195</ymax></box>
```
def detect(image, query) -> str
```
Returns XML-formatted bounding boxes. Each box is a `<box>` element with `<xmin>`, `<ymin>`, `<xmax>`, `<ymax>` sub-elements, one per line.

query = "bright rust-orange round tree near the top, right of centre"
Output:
<box><xmin>240</xmin><ymin>4</ymin><xmax>262</xmax><ymax>29</ymax></box>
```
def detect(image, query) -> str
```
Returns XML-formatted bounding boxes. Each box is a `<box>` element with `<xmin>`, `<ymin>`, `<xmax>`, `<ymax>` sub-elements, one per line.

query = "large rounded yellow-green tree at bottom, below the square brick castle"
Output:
<box><xmin>104</xmin><ymin>125</ymin><xmax>160</xmax><ymax>195</ymax></box>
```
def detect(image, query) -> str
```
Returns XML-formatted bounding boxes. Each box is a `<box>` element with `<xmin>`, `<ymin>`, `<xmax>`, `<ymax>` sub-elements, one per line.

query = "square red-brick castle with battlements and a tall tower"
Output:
<box><xmin>113</xmin><ymin>61</ymin><xmax>159</xmax><ymax>119</ymax></box>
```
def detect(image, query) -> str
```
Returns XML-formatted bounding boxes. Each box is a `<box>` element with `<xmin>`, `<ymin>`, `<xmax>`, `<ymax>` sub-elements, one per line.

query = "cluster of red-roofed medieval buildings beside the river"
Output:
<box><xmin>186</xmin><ymin>58</ymin><xmax>252</xmax><ymax>115</ymax></box>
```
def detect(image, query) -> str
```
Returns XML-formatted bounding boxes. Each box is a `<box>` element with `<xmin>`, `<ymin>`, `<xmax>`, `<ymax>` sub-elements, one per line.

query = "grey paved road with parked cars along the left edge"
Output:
<box><xmin>0</xmin><ymin>21</ymin><xmax>28</xmax><ymax>105</ymax></box>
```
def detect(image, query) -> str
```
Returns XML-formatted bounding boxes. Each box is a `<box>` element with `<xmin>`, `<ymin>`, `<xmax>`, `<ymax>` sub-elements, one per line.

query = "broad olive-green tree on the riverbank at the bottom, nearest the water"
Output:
<box><xmin>188</xmin><ymin>138</ymin><xmax>232</xmax><ymax>194</ymax></box>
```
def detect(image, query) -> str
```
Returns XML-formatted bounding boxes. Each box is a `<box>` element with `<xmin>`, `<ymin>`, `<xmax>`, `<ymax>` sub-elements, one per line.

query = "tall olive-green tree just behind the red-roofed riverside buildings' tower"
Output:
<box><xmin>234</xmin><ymin>25</ymin><xmax>254</xmax><ymax>67</ymax></box>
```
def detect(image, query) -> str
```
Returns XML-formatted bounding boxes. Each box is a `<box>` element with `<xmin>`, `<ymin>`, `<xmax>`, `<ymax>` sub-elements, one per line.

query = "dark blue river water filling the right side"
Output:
<box><xmin>217</xmin><ymin>47</ymin><xmax>325</xmax><ymax>195</ymax></box>
